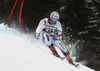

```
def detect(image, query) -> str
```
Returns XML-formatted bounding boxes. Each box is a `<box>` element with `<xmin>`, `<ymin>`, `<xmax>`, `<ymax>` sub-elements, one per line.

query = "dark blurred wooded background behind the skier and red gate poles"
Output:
<box><xmin>0</xmin><ymin>0</ymin><xmax>100</xmax><ymax>71</ymax></box>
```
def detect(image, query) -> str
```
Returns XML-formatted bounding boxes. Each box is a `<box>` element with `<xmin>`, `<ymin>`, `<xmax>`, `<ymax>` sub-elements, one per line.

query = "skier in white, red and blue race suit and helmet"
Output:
<box><xmin>36</xmin><ymin>11</ymin><xmax>75</xmax><ymax>65</ymax></box>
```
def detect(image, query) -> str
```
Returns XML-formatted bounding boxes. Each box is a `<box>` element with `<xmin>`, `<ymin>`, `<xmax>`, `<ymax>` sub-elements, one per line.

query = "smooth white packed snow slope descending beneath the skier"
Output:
<box><xmin>0</xmin><ymin>24</ymin><xmax>94</xmax><ymax>71</ymax></box>
